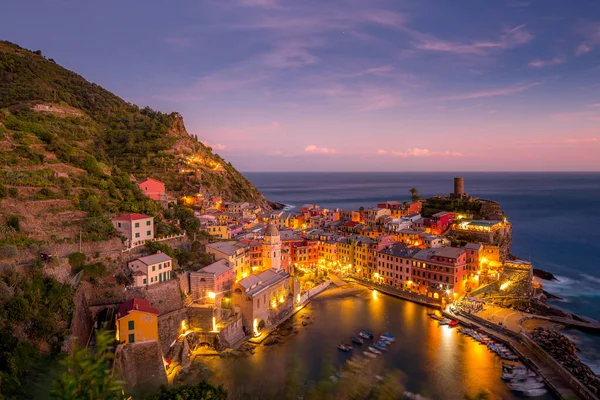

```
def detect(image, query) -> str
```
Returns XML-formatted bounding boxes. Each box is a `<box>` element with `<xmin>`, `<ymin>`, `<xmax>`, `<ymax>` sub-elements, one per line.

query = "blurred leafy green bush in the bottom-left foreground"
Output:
<box><xmin>51</xmin><ymin>331</ymin><xmax>129</xmax><ymax>400</ymax></box>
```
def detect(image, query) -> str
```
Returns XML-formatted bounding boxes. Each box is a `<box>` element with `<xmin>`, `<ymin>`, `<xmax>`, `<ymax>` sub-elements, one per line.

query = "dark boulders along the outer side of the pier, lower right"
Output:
<box><xmin>531</xmin><ymin>328</ymin><xmax>600</xmax><ymax>395</ymax></box>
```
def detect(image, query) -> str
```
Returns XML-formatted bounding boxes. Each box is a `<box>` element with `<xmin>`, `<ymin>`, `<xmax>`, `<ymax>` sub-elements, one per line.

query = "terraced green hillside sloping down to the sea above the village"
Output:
<box><xmin>0</xmin><ymin>41</ymin><xmax>272</xmax><ymax>245</ymax></box>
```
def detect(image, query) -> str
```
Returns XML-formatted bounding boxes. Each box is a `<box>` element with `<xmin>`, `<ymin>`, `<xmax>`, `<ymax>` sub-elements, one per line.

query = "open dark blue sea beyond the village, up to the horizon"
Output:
<box><xmin>244</xmin><ymin>172</ymin><xmax>600</xmax><ymax>373</ymax></box>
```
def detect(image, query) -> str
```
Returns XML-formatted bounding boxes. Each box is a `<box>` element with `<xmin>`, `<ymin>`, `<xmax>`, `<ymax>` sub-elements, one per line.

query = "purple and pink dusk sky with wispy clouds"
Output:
<box><xmin>0</xmin><ymin>0</ymin><xmax>600</xmax><ymax>171</ymax></box>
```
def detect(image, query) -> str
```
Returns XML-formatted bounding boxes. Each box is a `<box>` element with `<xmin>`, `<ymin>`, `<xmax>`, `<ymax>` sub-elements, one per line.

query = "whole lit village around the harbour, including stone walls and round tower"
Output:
<box><xmin>94</xmin><ymin>178</ymin><xmax>580</xmax><ymax>396</ymax></box>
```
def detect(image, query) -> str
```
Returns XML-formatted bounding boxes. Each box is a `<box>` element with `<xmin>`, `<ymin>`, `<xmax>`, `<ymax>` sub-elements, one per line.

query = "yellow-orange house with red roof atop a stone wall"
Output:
<box><xmin>117</xmin><ymin>299</ymin><xmax>158</xmax><ymax>343</ymax></box>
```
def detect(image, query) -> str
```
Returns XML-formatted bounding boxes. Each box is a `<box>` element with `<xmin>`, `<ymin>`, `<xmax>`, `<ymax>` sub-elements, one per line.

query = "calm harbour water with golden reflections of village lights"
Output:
<box><xmin>204</xmin><ymin>290</ymin><xmax>550</xmax><ymax>399</ymax></box>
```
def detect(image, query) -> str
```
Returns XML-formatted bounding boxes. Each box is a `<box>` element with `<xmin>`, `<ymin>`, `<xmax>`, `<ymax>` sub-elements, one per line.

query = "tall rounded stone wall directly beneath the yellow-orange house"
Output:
<box><xmin>115</xmin><ymin>340</ymin><xmax>167</xmax><ymax>398</ymax></box>
